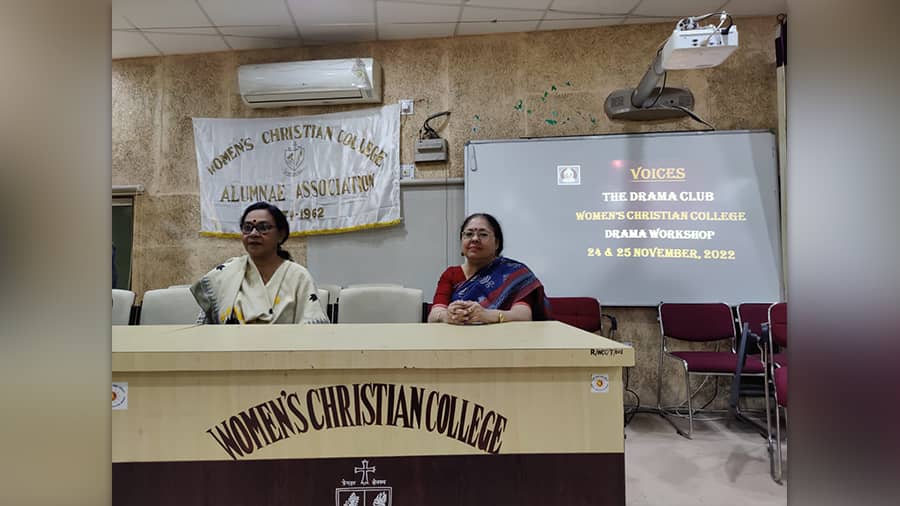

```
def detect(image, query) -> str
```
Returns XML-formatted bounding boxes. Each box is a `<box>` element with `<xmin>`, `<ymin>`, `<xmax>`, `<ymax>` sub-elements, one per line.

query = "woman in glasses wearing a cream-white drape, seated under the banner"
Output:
<box><xmin>191</xmin><ymin>202</ymin><xmax>328</xmax><ymax>324</ymax></box>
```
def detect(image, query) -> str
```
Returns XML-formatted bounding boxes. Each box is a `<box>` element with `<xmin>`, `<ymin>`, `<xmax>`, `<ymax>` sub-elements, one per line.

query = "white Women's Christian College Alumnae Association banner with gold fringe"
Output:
<box><xmin>193</xmin><ymin>104</ymin><xmax>400</xmax><ymax>237</ymax></box>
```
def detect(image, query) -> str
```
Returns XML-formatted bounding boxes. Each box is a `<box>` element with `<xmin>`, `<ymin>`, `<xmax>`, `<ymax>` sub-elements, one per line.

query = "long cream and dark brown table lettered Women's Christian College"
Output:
<box><xmin>112</xmin><ymin>322</ymin><xmax>634</xmax><ymax>506</ymax></box>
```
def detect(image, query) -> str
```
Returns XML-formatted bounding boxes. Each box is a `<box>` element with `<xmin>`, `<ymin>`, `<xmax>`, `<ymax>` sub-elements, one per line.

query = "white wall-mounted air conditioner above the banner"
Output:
<box><xmin>238</xmin><ymin>58</ymin><xmax>381</xmax><ymax>107</ymax></box>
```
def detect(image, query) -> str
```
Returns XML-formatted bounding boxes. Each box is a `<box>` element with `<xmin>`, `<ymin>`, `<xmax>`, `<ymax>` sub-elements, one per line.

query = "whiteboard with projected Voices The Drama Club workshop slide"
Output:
<box><xmin>465</xmin><ymin>131</ymin><xmax>783</xmax><ymax>306</ymax></box>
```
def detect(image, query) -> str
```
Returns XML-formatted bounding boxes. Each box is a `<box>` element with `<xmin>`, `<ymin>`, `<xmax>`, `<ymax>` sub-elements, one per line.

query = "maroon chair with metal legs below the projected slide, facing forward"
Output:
<box><xmin>656</xmin><ymin>302</ymin><xmax>765</xmax><ymax>439</ymax></box>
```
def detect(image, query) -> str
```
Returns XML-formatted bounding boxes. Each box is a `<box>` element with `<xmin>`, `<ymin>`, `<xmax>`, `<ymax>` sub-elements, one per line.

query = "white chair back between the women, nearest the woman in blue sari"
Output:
<box><xmin>338</xmin><ymin>286</ymin><xmax>422</xmax><ymax>323</ymax></box>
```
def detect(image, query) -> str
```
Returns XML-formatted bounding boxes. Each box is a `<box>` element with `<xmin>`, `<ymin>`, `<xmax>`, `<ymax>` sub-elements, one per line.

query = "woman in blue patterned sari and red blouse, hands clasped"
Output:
<box><xmin>428</xmin><ymin>213</ymin><xmax>549</xmax><ymax>325</ymax></box>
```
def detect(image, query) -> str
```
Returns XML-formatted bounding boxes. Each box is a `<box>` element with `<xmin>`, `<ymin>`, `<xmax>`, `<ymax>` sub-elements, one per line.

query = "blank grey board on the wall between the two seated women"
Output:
<box><xmin>306</xmin><ymin>180</ymin><xmax>464</xmax><ymax>301</ymax></box>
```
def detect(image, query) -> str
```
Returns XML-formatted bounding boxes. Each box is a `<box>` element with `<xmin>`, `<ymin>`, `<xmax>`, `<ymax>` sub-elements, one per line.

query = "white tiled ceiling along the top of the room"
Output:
<box><xmin>112</xmin><ymin>0</ymin><xmax>786</xmax><ymax>59</ymax></box>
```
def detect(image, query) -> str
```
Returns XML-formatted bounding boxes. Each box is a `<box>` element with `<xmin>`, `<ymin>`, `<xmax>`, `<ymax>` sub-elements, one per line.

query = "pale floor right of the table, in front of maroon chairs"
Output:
<box><xmin>625</xmin><ymin>413</ymin><xmax>787</xmax><ymax>506</ymax></box>
